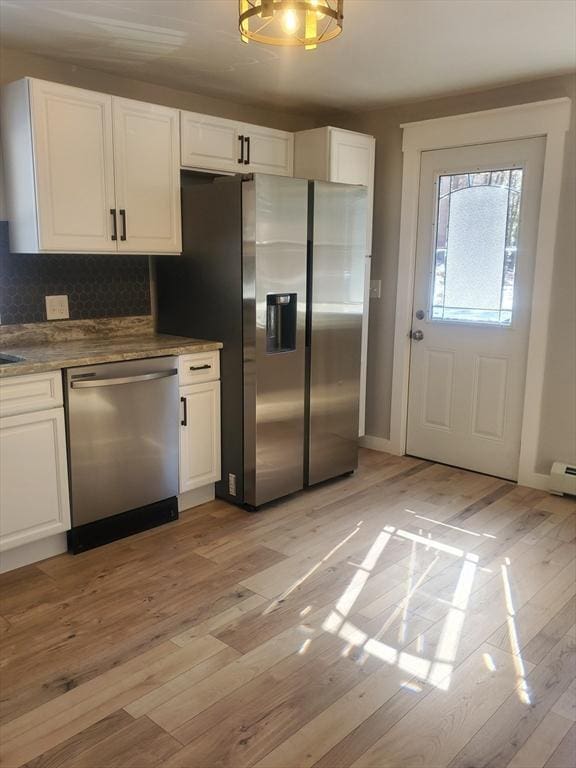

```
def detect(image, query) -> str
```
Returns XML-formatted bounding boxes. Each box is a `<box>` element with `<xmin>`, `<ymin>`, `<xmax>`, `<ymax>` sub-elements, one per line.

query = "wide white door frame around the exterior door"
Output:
<box><xmin>384</xmin><ymin>98</ymin><xmax>571</xmax><ymax>489</ymax></box>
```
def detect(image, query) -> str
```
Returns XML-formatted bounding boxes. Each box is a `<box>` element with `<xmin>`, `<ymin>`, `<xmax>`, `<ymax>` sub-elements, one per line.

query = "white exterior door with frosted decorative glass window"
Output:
<box><xmin>407</xmin><ymin>138</ymin><xmax>545</xmax><ymax>480</ymax></box>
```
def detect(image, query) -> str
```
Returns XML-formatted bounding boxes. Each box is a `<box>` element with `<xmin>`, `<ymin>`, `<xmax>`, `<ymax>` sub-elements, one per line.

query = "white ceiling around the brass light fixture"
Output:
<box><xmin>0</xmin><ymin>0</ymin><xmax>576</xmax><ymax>110</ymax></box>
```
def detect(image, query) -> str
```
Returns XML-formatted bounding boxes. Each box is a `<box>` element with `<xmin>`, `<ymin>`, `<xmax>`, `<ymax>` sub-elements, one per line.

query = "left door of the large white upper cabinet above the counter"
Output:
<box><xmin>30</xmin><ymin>80</ymin><xmax>116</xmax><ymax>252</ymax></box>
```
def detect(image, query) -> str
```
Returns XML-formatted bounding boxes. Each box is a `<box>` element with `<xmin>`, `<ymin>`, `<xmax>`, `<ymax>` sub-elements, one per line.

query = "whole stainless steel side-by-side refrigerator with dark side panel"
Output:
<box><xmin>155</xmin><ymin>174</ymin><xmax>366</xmax><ymax>508</ymax></box>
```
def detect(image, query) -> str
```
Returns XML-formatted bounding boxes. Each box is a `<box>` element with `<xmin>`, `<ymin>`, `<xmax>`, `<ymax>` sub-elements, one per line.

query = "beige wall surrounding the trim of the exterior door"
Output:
<box><xmin>340</xmin><ymin>75</ymin><xmax>576</xmax><ymax>472</ymax></box>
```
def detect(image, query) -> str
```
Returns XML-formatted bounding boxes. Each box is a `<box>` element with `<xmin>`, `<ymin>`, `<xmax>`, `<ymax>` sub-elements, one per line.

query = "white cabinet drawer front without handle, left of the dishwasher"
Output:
<box><xmin>0</xmin><ymin>371</ymin><xmax>63</xmax><ymax>416</ymax></box>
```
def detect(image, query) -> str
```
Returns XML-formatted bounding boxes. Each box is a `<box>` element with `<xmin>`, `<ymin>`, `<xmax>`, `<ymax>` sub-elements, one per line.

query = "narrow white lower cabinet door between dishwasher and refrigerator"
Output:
<box><xmin>180</xmin><ymin>381</ymin><xmax>220</xmax><ymax>493</ymax></box>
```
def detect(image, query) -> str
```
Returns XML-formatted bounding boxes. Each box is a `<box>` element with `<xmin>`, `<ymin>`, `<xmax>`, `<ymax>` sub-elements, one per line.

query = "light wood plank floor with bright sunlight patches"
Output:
<box><xmin>0</xmin><ymin>451</ymin><xmax>576</xmax><ymax>768</ymax></box>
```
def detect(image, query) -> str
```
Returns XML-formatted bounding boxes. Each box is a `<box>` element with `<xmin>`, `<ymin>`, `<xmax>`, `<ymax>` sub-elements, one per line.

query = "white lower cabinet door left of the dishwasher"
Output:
<box><xmin>0</xmin><ymin>408</ymin><xmax>70</xmax><ymax>549</ymax></box>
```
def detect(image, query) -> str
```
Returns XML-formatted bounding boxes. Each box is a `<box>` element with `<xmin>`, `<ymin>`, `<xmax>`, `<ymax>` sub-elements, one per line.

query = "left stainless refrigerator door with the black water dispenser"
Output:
<box><xmin>242</xmin><ymin>174</ymin><xmax>308</xmax><ymax>507</ymax></box>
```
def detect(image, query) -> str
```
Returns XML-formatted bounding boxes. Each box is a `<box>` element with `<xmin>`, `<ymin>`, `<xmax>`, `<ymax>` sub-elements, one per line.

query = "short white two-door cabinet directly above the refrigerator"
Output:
<box><xmin>180</xmin><ymin>112</ymin><xmax>294</xmax><ymax>176</ymax></box>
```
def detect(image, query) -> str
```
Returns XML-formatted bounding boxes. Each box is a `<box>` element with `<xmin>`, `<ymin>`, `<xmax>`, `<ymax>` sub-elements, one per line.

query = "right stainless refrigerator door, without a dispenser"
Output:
<box><xmin>307</xmin><ymin>181</ymin><xmax>367</xmax><ymax>485</ymax></box>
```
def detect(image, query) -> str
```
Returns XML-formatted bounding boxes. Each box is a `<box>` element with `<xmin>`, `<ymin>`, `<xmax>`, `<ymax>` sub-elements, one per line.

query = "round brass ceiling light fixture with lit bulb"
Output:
<box><xmin>238</xmin><ymin>0</ymin><xmax>344</xmax><ymax>51</ymax></box>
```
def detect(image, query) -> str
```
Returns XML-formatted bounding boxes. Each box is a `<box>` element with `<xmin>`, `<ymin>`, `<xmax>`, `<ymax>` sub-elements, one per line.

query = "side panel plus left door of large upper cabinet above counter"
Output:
<box><xmin>2</xmin><ymin>80</ymin><xmax>116</xmax><ymax>252</ymax></box>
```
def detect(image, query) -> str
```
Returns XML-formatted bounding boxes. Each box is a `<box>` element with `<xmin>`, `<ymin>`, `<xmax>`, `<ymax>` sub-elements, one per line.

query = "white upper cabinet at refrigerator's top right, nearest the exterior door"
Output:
<box><xmin>294</xmin><ymin>126</ymin><xmax>376</xmax><ymax>256</ymax></box>
